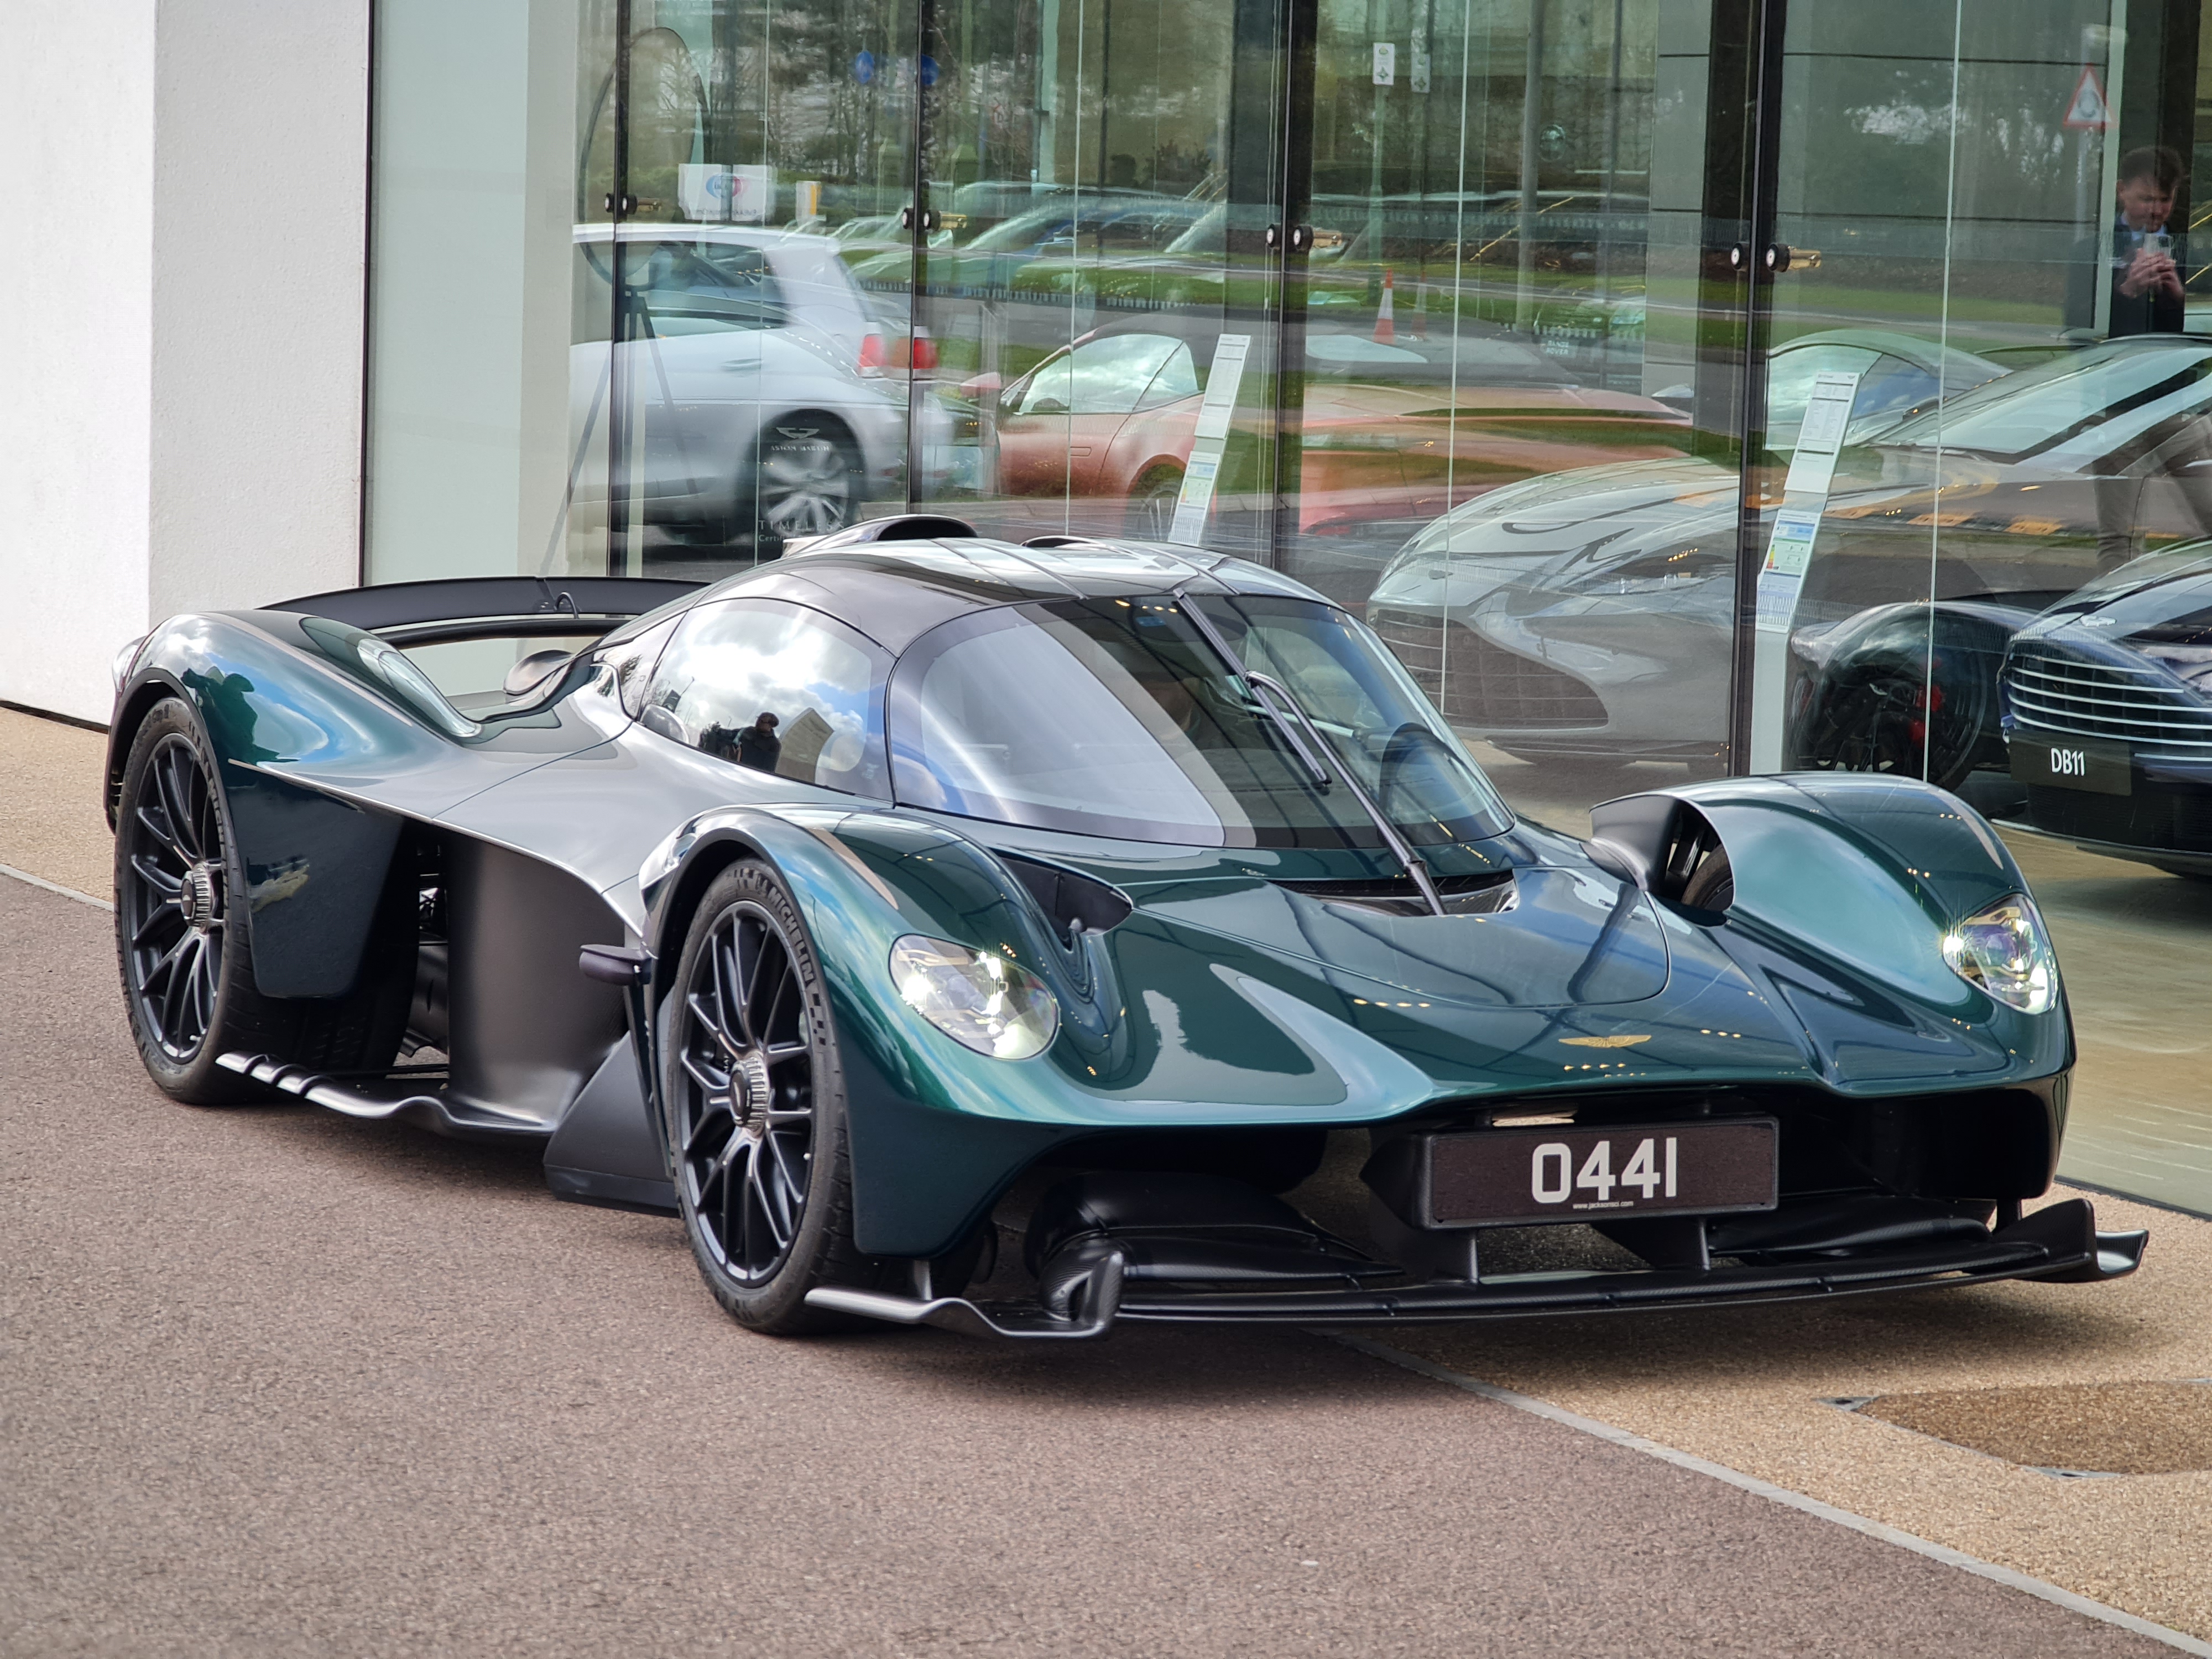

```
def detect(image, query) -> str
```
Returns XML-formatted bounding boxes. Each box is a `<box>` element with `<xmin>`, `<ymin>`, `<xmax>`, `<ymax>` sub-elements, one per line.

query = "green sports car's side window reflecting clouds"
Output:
<box><xmin>641</xmin><ymin>599</ymin><xmax>889</xmax><ymax>796</ymax></box>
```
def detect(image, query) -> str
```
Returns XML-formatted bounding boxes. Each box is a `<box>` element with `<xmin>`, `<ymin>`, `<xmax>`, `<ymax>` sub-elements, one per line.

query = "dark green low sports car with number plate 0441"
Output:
<box><xmin>108</xmin><ymin>526</ymin><xmax>2143</xmax><ymax>1336</ymax></box>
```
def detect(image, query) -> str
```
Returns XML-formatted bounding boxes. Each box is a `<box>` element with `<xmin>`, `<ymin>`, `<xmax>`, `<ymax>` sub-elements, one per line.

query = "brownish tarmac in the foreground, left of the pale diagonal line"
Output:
<box><xmin>0</xmin><ymin>880</ymin><xmax>2163</xmax><ymax>1659</ymax></box>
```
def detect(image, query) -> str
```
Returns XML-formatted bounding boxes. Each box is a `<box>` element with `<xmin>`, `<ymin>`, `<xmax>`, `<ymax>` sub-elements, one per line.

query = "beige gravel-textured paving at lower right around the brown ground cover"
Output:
<box><xmin>1389</xmin><ymin>1188</ymin><xmax>2212</xmax><ymax>1639</ymax></box>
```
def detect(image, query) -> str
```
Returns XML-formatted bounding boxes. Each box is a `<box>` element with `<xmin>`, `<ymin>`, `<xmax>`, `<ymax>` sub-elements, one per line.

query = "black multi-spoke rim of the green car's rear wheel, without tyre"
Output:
<box><xmin>115</xmin><ymin>730</ymin><xmax>230</xmax><ymax>1068</ymax></box>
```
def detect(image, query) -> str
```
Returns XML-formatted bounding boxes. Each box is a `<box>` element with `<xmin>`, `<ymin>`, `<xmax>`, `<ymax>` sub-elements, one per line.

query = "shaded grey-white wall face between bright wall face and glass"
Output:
<box><xmin>150</xmin><ymin>0</ymin><xmax>369</xmax><ymax>617</ymax></box>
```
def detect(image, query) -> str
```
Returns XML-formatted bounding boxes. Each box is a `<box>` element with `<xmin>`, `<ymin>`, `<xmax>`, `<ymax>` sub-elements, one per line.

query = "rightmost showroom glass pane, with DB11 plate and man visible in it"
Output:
<box><xmin>1752</xmin><ymin>0</ymin><xmax>2212</xmax><ymax>1208</ymax></box>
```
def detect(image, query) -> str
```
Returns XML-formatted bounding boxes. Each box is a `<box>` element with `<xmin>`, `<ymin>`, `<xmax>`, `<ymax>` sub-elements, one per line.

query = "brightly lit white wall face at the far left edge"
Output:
<box><xmin>0</xmin><ymin>0</ymin><xmax>155</xmax><ymax>719</ymax></box>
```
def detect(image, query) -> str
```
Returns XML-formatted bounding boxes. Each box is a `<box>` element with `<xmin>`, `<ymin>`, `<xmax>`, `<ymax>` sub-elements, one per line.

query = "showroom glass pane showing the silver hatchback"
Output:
<box><xmin>580</xmin><ymin>0</ymin><xmax>916</xmax><ymax>577</ymax></box>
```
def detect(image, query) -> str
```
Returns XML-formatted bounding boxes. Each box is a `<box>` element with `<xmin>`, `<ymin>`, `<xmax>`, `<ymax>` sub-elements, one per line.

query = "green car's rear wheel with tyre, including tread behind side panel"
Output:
<box><xmin>115</xmin><ymin>697</ymin><xmax>414</xmax><ymax>1106</ymax></box>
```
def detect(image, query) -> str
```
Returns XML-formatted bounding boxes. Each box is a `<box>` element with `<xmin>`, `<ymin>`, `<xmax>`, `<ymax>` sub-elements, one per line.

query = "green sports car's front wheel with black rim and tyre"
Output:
<box><xmin>661</xmin><ymin>860</ymin><xmax>878</xmax><ymax>1334</ymax></box>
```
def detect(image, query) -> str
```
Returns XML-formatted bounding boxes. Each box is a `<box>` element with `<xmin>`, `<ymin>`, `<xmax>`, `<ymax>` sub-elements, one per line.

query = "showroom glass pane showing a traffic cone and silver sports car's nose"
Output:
<box><xmin>1310</xmin><ymin>0</ymin><xmax>1743</xmax><ymax>827</ymax></box>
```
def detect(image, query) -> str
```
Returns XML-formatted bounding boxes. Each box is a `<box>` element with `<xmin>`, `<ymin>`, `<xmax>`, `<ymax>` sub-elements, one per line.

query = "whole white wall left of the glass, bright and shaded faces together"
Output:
<box><xmin>0</xmin><ymin>0</ymin><xmax>367</xmax><ymax>719</ymax></box>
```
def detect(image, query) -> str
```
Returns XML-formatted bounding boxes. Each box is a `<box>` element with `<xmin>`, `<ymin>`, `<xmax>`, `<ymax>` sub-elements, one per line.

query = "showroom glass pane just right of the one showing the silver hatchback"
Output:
<box><xmin>902</xmin><ymin>0</ymin><xmax>1283</xmax><ymax>557</ymax></box>
